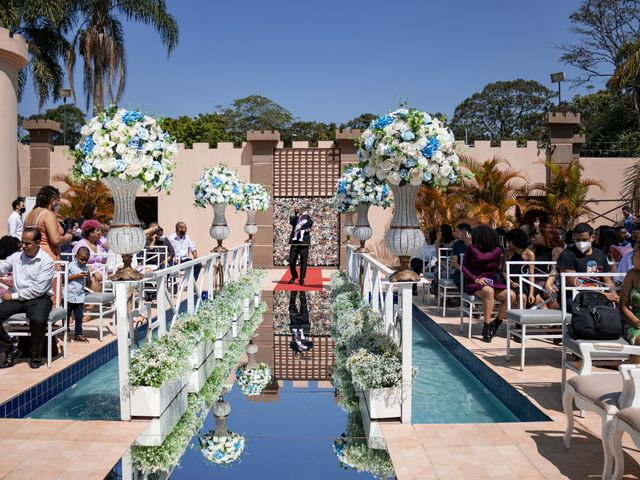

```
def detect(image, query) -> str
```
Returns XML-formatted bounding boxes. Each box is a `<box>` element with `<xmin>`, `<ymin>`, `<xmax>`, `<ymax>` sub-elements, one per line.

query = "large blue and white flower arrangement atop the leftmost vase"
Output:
<box><xmin>70</xmin><ymin>106</ymin><xmax>178</xmax><ymax>191</ymax></box>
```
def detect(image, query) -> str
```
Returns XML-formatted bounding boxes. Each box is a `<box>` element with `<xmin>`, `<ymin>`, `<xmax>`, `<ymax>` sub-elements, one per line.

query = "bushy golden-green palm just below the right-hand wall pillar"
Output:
<box><xmin>528</xmin><ymin>160</ymin><xmax>604</xmax><ymax>229</ymax></box>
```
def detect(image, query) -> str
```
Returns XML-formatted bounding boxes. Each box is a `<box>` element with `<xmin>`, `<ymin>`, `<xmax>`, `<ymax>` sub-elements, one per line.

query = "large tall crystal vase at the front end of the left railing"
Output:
<box><xmin>102</xmin><ymin>177</ymin><xmax>146</xmax><ymax>281</ymax></box>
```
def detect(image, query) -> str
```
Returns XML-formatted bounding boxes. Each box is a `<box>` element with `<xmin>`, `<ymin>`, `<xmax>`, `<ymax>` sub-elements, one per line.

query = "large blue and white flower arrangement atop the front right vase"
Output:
<box><xmin>357</xmin><ymin>108</ymin><xmax>460</xmax><ymax>188</ymax></box>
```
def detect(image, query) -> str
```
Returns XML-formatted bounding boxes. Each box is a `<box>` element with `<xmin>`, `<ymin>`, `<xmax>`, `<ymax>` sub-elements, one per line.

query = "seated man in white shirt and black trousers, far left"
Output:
<box><xmin>0</xmin><ymin>228</ymin><xmax>54</xmax><ymax>368</ymax></box>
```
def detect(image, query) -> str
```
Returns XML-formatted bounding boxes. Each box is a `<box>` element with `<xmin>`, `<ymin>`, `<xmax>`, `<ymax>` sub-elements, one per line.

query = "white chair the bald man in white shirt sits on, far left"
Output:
<box><xmin>5</xmin><ymin>261</ymin><xmax>69</xmax><ymax>368</ymax></box>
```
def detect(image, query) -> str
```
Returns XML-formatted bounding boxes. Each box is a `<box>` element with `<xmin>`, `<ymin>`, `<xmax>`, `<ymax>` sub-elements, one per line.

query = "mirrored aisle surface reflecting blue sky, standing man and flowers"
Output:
<box><xmin>116</xmin><ymin>291</ymin><xmax>393</xmax><ymax>480</ymax></box>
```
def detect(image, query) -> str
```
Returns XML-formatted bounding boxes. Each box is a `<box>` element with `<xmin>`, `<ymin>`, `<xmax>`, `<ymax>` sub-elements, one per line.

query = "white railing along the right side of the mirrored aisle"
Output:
<box><xmin>346</xmin><ymin>245</ymin><xmax>413</xmax><ymax>423</ymax></box>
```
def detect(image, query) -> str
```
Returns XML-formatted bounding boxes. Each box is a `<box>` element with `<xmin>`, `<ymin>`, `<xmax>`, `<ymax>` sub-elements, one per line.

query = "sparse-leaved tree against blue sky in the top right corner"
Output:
<box><xmin>560</xmin><ymin>0</ymin><xmax>640</xmax><ymax>125</ymax></box>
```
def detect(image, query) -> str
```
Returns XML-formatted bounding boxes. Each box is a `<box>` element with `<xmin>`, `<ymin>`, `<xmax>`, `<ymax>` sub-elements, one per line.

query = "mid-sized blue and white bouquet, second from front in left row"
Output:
<box><xmin>193</xmin><ymin>165</ymin><xmax>243</xmax><ymax>207</ymax></box>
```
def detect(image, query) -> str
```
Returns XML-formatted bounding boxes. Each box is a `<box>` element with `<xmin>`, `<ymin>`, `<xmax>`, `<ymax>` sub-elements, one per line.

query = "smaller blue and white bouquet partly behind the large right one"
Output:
<box><xmin>333</xmin><ymin>166</ymin><xmax>392</xmax><ymax>213</ymax></box>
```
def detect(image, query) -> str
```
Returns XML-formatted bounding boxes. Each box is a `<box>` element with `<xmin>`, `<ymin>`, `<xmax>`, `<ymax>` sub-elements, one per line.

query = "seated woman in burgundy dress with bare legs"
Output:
<box><xmin>462</xmin><ymin>225</ymin><xmax>515</xmax><ymax>343</ymax></box>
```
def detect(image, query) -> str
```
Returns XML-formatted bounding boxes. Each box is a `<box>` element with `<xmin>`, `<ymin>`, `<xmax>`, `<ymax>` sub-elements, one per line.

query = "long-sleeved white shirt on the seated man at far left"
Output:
<box><xmin>0</xmin><ymin>248</ymin><xmax>54</xmax><ymax>300</ymax></box>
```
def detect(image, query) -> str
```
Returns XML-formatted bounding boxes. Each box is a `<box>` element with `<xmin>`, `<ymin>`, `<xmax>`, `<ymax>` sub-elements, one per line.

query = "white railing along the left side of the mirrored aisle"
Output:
<box><xmin>113</xmin><ymin>243</ymin><xmax>252</xmax><ymax>420</ymax></box>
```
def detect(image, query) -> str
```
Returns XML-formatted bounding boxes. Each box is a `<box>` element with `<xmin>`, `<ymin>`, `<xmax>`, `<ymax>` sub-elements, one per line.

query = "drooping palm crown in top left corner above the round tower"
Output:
<box><xmin>0</xmin><ymin>0</ymin><xmax>76</xmax><ymax>106</ymax></box>
